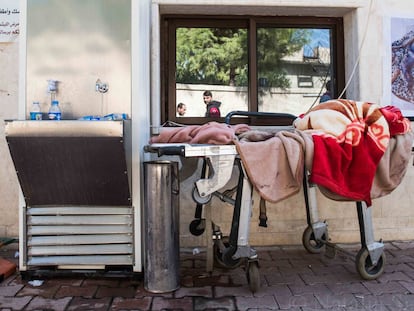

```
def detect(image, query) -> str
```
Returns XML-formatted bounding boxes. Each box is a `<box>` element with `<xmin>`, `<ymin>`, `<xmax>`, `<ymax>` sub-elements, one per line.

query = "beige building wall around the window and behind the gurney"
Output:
<box><xmin>0</xmin><ymin>0</ymin><xmax>414</xmax><ymax>251</ymax></box>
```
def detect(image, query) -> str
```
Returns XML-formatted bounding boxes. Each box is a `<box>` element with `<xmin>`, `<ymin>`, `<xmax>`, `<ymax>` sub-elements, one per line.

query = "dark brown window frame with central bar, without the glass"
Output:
<box><xmin>160</xmin><ymin>14</ymin><xmax>345</xmax><ymax>125</ymax></box>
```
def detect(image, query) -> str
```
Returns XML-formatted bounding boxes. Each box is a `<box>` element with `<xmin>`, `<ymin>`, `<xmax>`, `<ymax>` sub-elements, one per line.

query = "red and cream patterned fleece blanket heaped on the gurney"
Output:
<box><xmin>295</xmin><ymin>100</ymin><xmax>410</xmax><ymax>206</ymax></box>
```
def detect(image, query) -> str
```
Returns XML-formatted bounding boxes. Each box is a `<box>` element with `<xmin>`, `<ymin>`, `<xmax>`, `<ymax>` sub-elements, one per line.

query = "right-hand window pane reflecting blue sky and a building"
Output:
<box><xmin>256</xmin><ymin>27</ymin><xmax>332</xmax><ymax>115</ymax></box>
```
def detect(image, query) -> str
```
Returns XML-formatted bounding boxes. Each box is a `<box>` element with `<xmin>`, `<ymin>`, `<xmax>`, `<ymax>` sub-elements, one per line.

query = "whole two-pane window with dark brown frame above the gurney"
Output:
<box><xmin>161</xmin><ymin>16</ymin><xmax>344</xmax><ymax>124</ymax></box>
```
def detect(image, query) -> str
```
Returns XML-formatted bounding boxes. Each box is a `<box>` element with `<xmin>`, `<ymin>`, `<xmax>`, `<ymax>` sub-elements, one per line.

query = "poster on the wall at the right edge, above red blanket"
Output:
<box><xmin>391</xmin><ymin>18</ymin><xmax>414</xmax><ymax>120</ymax></box>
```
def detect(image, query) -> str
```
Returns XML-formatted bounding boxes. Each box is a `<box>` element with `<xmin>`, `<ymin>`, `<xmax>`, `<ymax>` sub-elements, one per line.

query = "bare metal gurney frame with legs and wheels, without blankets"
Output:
<box><xmin>146</xmin><ymin>111</ymin><xmax>410</xmax><ymax>291</ymax></box>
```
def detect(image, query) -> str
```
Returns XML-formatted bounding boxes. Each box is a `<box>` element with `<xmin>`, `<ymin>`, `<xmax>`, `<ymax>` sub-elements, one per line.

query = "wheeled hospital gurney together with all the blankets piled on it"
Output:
<box><xmin>146</xmin><ymin>100</ymin><xmax>413</xmax><ymax>292</ymax></box>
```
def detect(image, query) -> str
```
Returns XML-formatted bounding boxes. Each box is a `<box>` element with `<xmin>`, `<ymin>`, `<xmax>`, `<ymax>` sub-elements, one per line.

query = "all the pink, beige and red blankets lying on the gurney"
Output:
<box><xmin>150</xmin><ymin>99</ymin><xmax>413</xmax><ymax>206</ymax></box>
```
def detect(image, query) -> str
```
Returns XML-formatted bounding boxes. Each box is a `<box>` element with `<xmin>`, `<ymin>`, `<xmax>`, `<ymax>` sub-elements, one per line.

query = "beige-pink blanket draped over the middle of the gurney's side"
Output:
<box><xmin>235</xmin><ymin>131</ymin><xmax>313</xmax><ymax>203</ymax></box>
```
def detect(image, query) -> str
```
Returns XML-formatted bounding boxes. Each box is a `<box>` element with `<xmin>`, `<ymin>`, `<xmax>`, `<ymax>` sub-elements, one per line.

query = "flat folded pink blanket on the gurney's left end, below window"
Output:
<box><xmin>150</xmin><ymin>122</ymin><xmax>250</xmax><ymax>145</ymax></box>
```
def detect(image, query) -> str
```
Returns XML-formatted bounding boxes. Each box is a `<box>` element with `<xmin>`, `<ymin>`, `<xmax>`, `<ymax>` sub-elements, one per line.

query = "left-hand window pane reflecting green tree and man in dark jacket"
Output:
<box><xmin>175</xmin><ymin>27</ymin><xmax>248</xmax><ymax>117</ymax></box>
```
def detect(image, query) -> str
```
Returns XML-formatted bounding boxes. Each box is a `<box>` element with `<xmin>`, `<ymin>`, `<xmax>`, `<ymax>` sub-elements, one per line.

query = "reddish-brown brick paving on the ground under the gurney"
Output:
<box><xmin>0</xmin><ymin>241</ymin><xmax>414</xmax><ymax>311</ymax></box>
